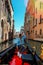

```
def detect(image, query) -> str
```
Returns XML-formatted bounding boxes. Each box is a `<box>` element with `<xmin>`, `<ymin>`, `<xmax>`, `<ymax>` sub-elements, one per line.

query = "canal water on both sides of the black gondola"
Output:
<box><xmin>0</xmin><ymin>38</ymin><xmax>43</xmax><ymax>59</ymax></box>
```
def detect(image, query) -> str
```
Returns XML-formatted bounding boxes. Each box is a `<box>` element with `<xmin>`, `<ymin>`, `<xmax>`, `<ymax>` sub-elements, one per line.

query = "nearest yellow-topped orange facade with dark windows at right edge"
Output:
<box><xmin>33</xmin><ymin>0</ymin><xmax>43</xmax><ymax>41</ymax></box>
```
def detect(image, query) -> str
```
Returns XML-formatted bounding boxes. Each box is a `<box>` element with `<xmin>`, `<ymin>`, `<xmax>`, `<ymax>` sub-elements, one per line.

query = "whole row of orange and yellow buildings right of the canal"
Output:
<box><xmin>24</xmin><ymin>0</ymin><xmax>43</xmax><ymax>41</ymax></box>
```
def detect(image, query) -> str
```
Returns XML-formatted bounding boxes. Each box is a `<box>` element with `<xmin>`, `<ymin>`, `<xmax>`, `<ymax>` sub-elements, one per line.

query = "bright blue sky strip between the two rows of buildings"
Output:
<box><xmin>12</xmin><ymin>0</ymin><xmax>28</xmax><ymax>31</ymax></box>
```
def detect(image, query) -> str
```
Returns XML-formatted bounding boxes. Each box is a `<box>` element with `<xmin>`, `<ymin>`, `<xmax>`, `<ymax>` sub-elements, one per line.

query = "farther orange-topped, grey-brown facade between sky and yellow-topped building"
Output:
<box><xmin>24</xmin><ymin>0</ymin><xmax>35</xmax><ymax>39</ymax></box>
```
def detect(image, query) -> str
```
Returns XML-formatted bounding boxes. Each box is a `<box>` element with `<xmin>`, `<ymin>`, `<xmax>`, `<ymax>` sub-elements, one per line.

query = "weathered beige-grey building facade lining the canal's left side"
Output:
<box><xmin>0</xmin><ymin>0</ymin><xmax>14</xmax><ymax>41</ymax></box>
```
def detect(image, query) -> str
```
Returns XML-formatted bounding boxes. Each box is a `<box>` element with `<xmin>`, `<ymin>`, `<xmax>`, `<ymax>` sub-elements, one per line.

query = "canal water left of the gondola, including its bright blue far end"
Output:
<box><xmin>0</xmin><ymin>38</ymin><xmax>19</xmax><ymax>52</ymax></box>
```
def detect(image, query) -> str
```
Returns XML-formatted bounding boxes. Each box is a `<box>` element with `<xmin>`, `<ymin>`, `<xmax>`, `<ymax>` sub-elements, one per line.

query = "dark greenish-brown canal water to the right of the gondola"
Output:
<box><xmin>29</xmin><ymin>40</ymin><xmax>43</xmax><ymax>57</ymax></box>
